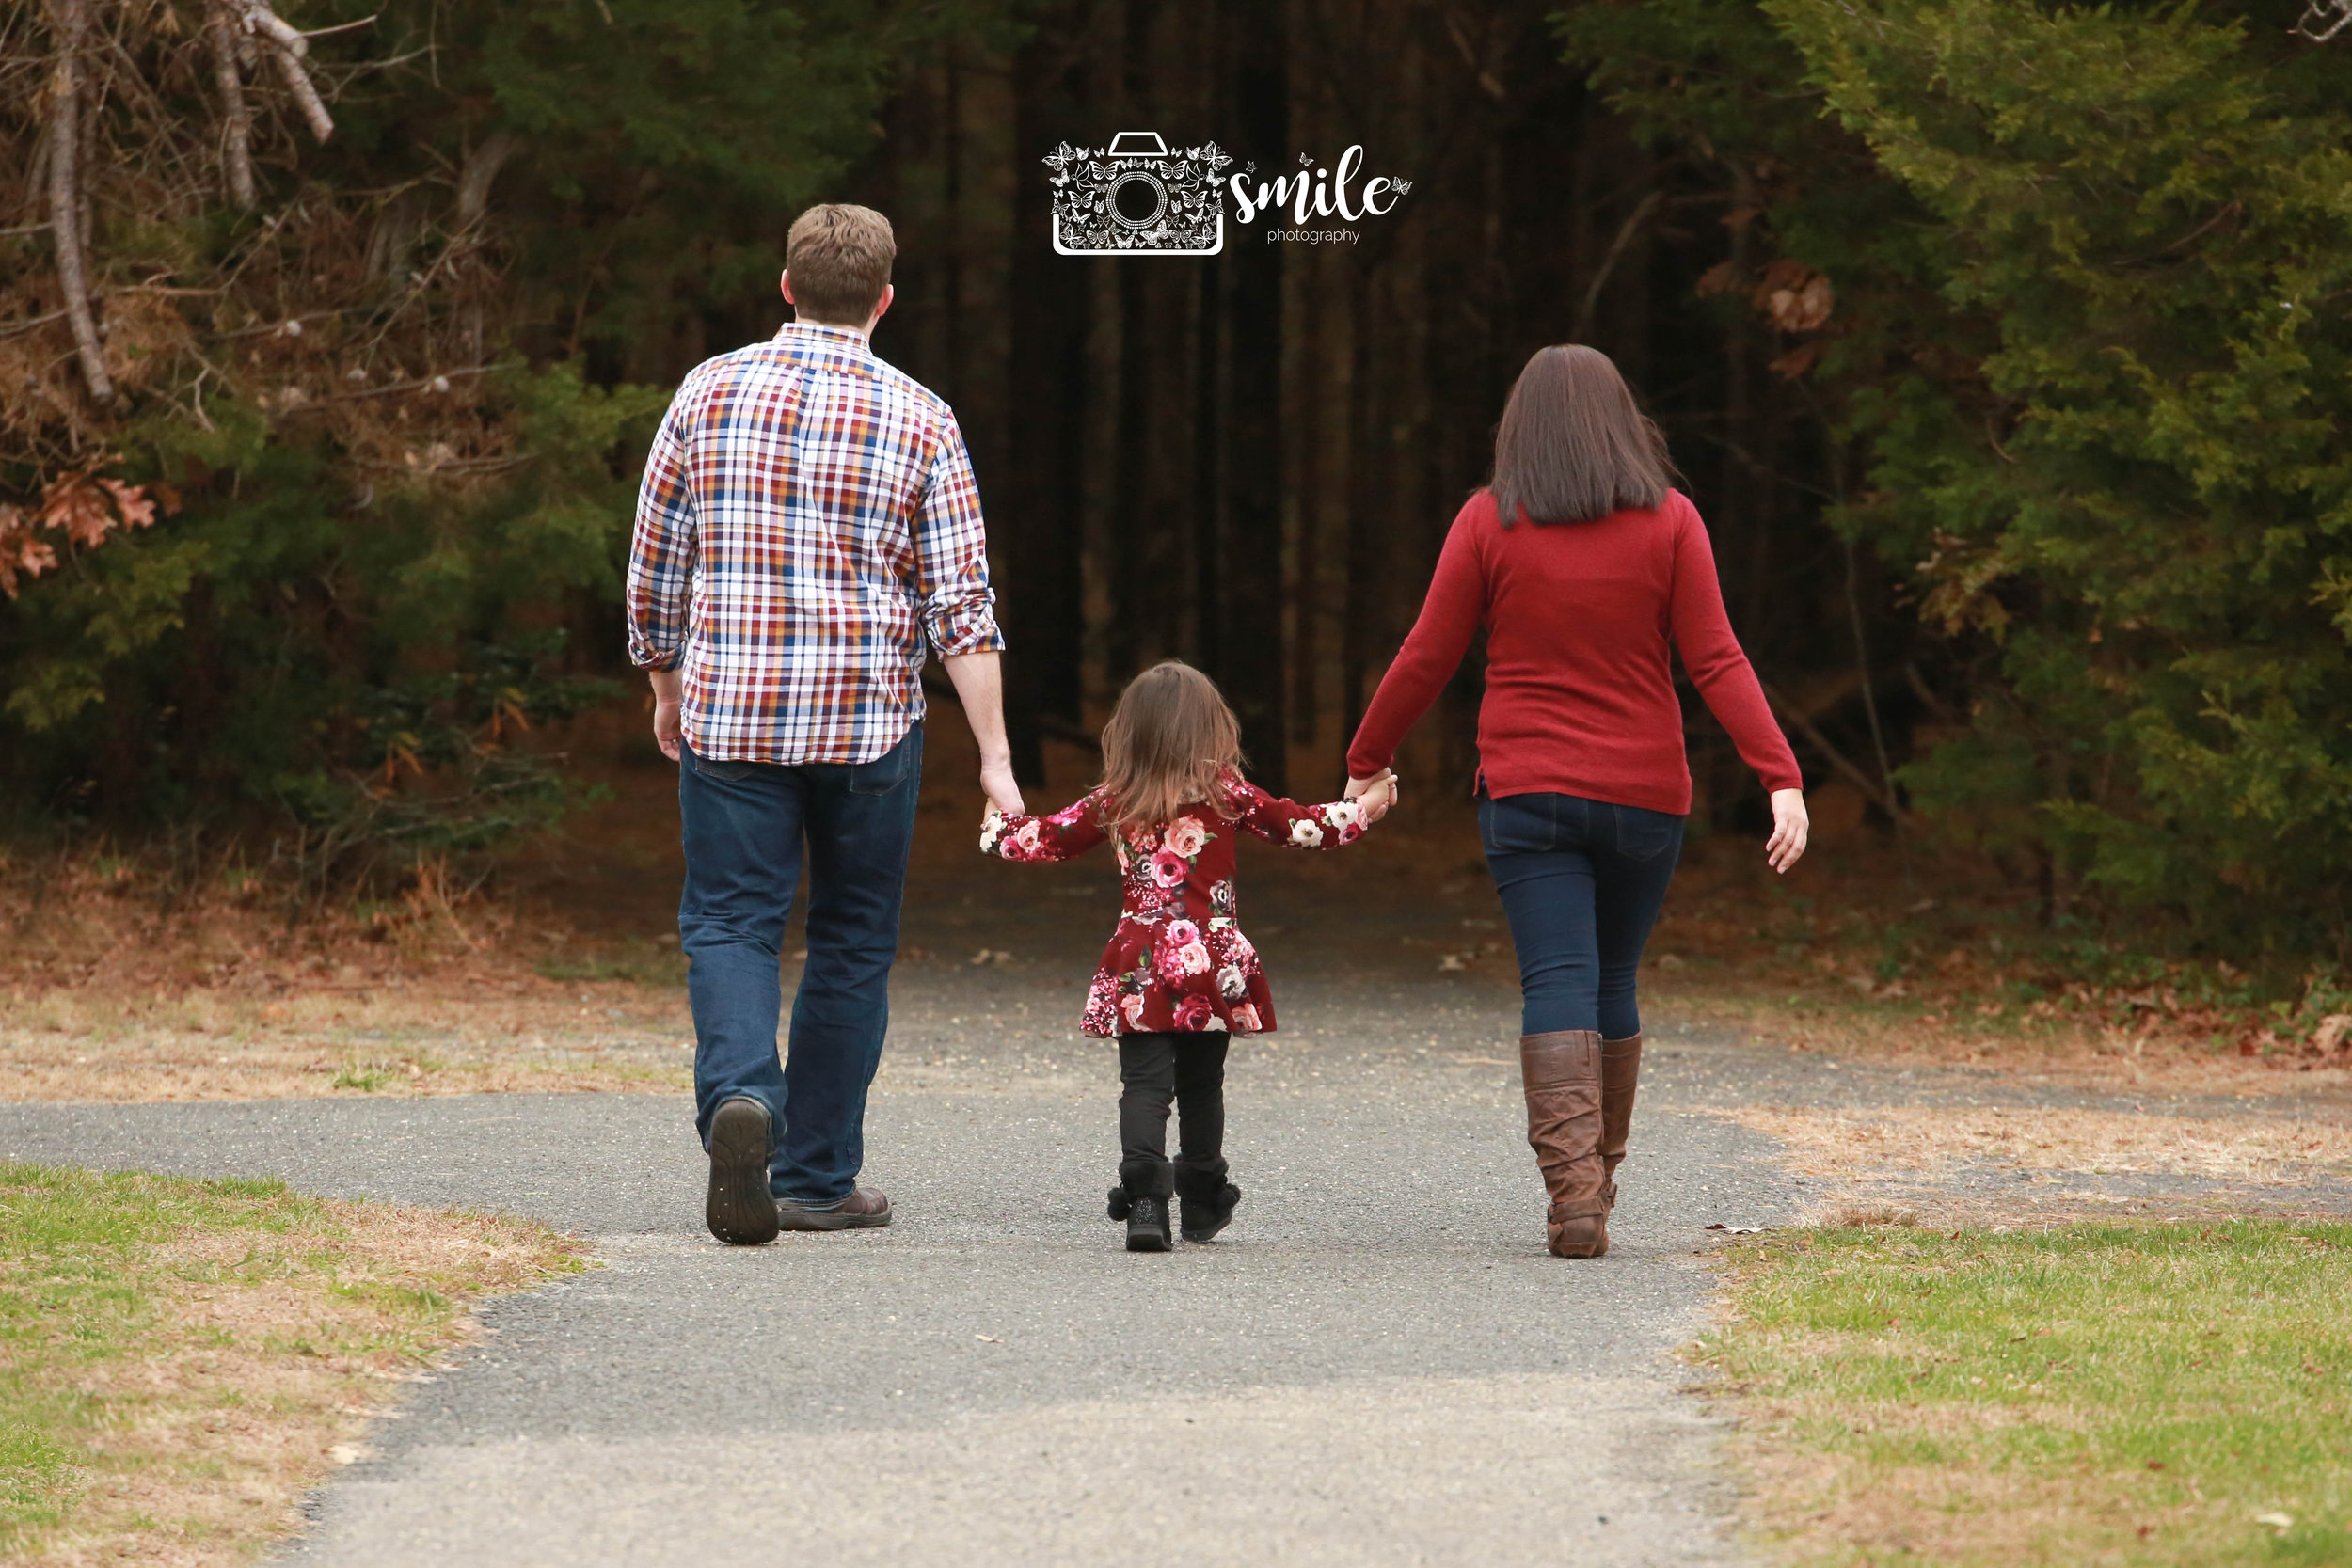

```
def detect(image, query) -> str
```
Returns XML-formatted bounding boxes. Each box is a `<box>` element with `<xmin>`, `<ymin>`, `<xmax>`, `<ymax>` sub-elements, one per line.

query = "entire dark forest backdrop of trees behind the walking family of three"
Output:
<box><xmin>0</xmin><ymin>0</ymin><xmax>2352</xmax><ymax>952</ymax></box>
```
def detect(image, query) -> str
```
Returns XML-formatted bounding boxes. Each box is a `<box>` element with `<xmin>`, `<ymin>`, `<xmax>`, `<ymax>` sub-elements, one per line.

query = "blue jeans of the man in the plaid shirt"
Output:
<box><xmin>677</xmin><ymin>726</ymin><xmax>922</xmax><ymax>1209</ymax></box>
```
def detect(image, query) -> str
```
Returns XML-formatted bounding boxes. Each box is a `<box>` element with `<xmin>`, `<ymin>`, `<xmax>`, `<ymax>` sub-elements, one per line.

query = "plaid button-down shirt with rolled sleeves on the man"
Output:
<box><xmin>628</xmin><ymin>322</ymin><xmax>1005</xmax><ymax>764</ymax></box>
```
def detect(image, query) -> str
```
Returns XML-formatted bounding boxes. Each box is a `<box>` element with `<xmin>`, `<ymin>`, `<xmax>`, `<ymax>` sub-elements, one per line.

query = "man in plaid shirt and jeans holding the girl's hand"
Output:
<box><xmin>628</xmin><ymin>207</ymin><xmax>1021</xmax><ymax>1243</ymax></box>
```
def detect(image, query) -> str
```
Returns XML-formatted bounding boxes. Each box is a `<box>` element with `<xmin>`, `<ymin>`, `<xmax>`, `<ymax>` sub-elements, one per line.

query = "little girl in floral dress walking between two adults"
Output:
<box><xmin>981</xmin><ymin>660</ymin><xmax>1395</xmax><ymax>1253</ymax></box>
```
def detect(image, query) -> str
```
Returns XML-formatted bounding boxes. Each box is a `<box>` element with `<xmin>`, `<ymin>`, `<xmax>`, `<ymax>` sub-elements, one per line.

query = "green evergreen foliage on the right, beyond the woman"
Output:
<box><xmin>1562</xmin><ymin>0</ymin><xmax>2352</xmax><ymax>947</ymax></box>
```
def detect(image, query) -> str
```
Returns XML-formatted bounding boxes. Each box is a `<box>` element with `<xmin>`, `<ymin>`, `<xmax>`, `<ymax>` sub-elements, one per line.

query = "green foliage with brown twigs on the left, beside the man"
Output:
<box><xmin>0</xmin><ymin>0</ymin><xmax>953</xmax><ymax>863</ymax></box>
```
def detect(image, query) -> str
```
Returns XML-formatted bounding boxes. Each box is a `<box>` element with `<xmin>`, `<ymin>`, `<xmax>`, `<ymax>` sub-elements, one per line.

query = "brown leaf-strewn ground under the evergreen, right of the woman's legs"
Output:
<box><xmin>1642</xmin><ymin>830</ymin><xmax>2352</xmax><ymax>1093</ymax></box>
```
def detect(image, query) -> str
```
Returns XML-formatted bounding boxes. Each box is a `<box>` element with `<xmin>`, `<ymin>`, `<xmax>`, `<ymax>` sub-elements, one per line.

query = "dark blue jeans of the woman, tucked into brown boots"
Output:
<box><xmin>1477</xmin><ymin>790</ymin><xmax>1682</xmax><ymax>1039</ymax></box>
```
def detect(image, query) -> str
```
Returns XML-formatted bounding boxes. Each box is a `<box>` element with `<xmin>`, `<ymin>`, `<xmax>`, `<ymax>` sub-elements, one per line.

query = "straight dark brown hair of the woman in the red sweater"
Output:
<box><xmin>1489</xmin><ymin>343</ymin><xmax>1675</xmax><ymax>529</ymax></box>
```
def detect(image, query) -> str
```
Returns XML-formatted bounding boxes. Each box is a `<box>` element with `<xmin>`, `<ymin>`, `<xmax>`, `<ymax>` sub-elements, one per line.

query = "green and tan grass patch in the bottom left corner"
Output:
<box><xmin>0</xmin><ymin>1166</ymin><xmax>583</xmax><ymax>1566</ymax></box>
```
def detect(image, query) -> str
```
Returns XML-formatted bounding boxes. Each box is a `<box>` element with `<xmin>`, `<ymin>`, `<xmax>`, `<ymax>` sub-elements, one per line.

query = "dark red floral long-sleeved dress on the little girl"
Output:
<box><xmin>981</xmin><ymin>773</ymin><xmax>1364</xmax><ymax>1037</ymax></box>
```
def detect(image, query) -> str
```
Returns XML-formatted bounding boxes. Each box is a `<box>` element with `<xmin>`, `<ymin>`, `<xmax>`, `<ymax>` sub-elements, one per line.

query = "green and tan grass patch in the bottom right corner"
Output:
<box><xmin>1706</xmin><ymin>1220</ymin><xmax>2352</xmax><ymax>1566</ymax></box>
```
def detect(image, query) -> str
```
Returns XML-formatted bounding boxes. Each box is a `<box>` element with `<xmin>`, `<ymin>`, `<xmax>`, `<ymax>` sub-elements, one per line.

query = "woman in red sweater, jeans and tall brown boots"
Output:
<box><xmin>1348</xmin><ymin>343</ymin><xmax>1806</xmax><ymax>1258</ymax></box>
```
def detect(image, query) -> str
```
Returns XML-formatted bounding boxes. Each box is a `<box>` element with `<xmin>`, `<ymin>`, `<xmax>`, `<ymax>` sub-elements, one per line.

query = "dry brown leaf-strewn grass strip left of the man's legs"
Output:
<box><xmin>0</xmin><ymin>858</ymin><xmax>691</xmax><ymax>1101</ymax></box>
